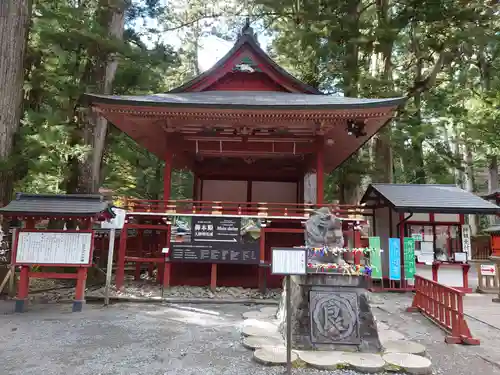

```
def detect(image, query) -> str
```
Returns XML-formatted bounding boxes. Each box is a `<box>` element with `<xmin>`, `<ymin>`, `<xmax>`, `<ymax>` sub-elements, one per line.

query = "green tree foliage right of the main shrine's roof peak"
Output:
<box><xmin>254</xmin><ymin>0</ymin><xmax>500</xmax><ymax>203</ymax></box>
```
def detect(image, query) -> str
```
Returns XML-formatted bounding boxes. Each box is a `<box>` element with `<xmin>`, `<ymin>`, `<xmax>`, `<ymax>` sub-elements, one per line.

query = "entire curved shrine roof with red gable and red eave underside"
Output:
<box><xmin>86</xmin><ymin>24</ymin><xmax>405</xmax><ymax>172</ymax></box>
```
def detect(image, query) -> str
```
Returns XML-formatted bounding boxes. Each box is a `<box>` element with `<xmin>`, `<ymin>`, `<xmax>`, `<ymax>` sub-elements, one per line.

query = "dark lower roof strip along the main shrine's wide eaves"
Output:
<box><xmin>86</xmin><ymin>91</ymin><xmax>404</xmax><ymax>109</ymax></box>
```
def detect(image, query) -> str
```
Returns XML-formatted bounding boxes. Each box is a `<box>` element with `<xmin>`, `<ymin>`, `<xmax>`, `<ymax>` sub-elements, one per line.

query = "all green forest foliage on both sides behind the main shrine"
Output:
<box><xmin>9</xmin><ymin>0</ymin><xmax>500</xmax><ymax>212</ymax></box>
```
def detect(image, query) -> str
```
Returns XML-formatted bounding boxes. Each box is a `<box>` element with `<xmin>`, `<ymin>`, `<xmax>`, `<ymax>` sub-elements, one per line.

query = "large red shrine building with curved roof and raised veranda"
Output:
<box><xmin>87</xmin><ymin>25</ymin><xmax>403</xmax><ymax>288</ymax></box>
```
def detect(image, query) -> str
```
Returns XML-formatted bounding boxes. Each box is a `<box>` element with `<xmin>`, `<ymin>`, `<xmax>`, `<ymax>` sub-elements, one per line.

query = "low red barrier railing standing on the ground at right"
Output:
<box><xmin>407</xmin><ymin>275</ymin><xmax>479</xmax><ymax>345</ymax></box>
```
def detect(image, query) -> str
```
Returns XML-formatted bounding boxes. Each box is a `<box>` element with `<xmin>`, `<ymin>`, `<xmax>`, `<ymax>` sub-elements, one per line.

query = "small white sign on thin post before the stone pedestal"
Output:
<box><xmin>271</xmin><ymin>247</ymin><xmax>307</xmax><ymax>375</ymax></box>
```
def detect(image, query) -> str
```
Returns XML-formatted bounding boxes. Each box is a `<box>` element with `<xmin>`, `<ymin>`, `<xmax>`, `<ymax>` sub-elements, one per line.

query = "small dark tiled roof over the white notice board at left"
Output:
<box><xmin>0</xmin><ymin>193</ymin><xmax>108</xmax><ymax>216</ymax></box>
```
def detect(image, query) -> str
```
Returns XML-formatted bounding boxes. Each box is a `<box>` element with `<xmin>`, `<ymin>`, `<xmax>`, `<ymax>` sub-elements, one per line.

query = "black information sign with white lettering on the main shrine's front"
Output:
<box><xmin>170</xmin><ymin>216</ymin><xmax>261</xmax><ymax>264</ymax></box>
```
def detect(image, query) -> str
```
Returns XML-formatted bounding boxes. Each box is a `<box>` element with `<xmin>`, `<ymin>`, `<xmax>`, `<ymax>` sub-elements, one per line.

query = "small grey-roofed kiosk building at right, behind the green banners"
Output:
<box><xmin>361</xmin><ymin>184</ymin><xmax>500</xmax><ymax>292</ymax></box>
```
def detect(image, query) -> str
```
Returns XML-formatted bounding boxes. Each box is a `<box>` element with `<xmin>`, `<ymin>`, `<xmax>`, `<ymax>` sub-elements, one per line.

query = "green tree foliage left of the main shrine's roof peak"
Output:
<box><xmin>19</xmin><ymin>0</ymin><xmax>185</xmax><ymax>199</ymax></box>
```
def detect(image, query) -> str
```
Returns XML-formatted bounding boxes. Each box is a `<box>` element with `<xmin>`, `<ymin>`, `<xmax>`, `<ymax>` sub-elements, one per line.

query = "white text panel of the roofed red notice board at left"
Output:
<box><xmin>13</xmin><ymin>230</ymin><xmax>93</xmax><ymax>266</ymax></box>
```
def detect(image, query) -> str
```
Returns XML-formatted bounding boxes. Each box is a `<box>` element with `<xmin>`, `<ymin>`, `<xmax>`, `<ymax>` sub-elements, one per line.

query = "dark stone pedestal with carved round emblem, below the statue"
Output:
<box><xmin>278</xmin><ymin>273</ymin><xmax>382</xmax><ymax>353</ymax></box>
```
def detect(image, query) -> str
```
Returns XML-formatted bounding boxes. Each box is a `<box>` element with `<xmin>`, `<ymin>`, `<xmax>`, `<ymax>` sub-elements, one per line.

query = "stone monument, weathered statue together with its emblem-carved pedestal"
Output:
<box><xmin>278</xmin><ymin>207</ymin><xmax>381</xmax><ymax>353</ymax></box>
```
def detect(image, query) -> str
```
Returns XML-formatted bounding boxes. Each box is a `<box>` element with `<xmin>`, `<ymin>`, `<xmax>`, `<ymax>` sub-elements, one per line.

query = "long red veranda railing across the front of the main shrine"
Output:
<box><xmin>123</xmin><ymin>199</ymin><xmax>372</xmax><ymax>220</ymax></box>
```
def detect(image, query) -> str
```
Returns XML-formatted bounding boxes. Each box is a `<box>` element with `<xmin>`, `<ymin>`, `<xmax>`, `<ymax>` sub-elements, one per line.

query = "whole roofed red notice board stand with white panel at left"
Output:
<box><xmin>0</xmin><ymin>193</ymin><xmax>109</xmax><ymax>312</ymax></box>
